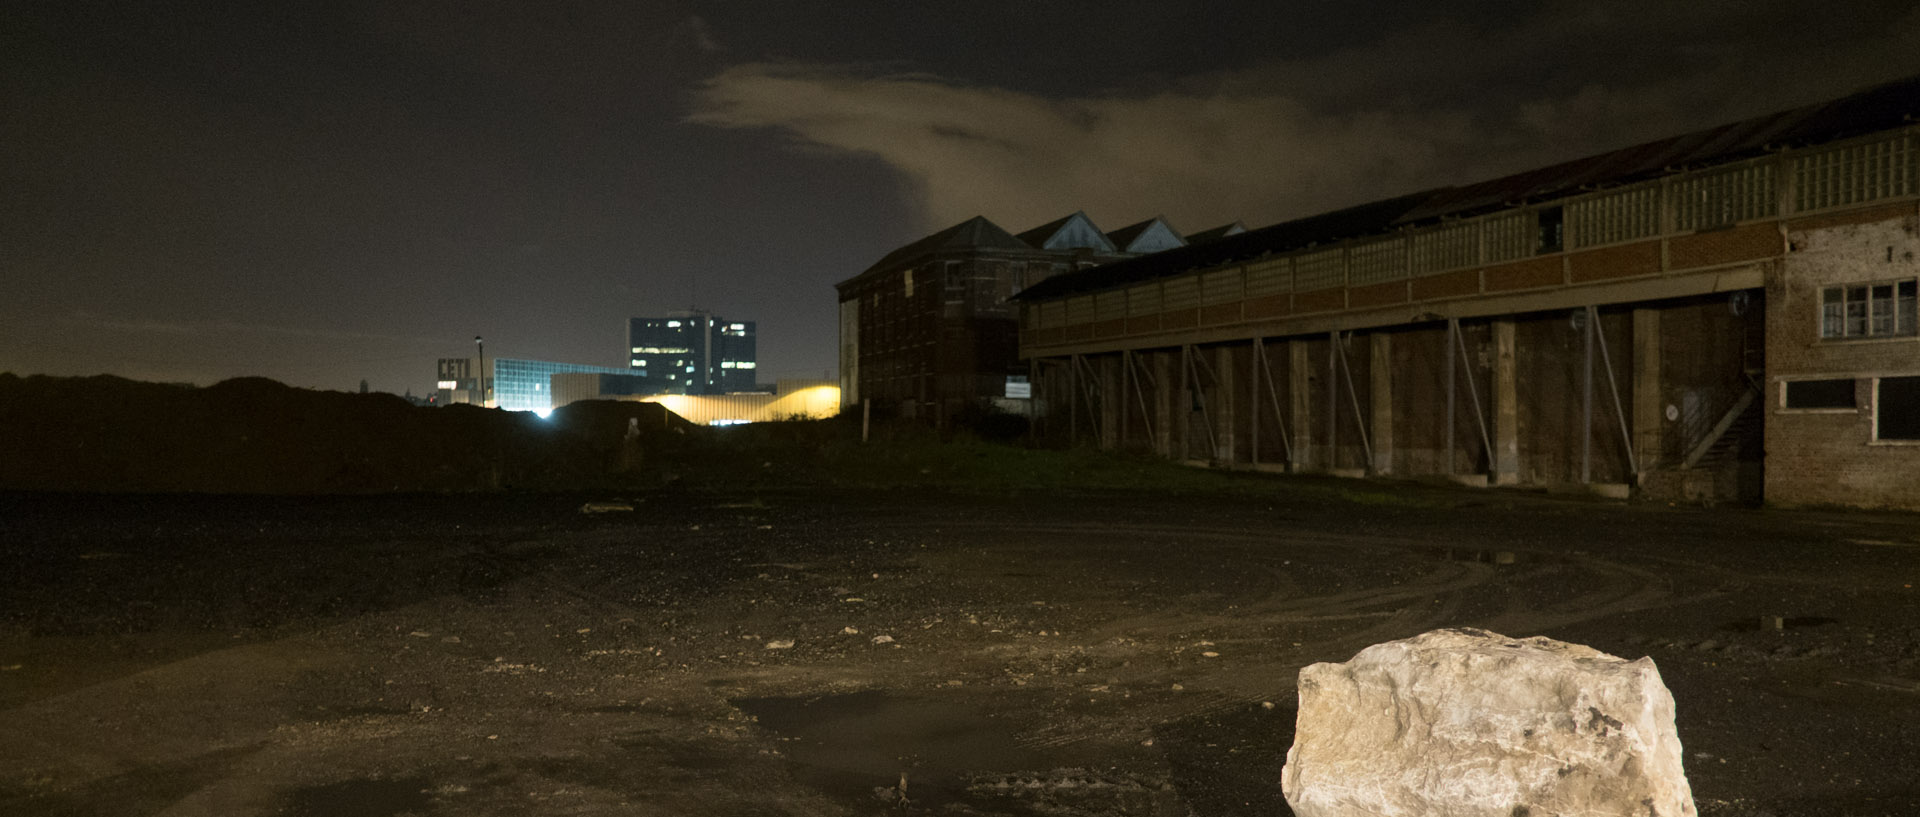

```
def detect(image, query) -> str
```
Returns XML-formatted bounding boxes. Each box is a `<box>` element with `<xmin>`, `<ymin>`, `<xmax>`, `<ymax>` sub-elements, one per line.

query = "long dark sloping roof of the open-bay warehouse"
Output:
<box><xmin>1016</xmin><ymin>77</ymin><xmax>1920</xmax><ymax>301</ymax></box>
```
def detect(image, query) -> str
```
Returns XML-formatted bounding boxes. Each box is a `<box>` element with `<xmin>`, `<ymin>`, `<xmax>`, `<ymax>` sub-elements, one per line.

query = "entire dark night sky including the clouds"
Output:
<box><xmin>0</xmin><ymin>0</ymin><xmax>1920</xmax><ymax>393</ymax></box>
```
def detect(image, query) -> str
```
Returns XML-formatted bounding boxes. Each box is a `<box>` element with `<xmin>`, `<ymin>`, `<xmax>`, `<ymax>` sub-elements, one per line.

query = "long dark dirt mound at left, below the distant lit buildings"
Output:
<box><xmin>0</xmin><ymin>374</ymin><xmax>687</xmax><ymax>493</ymax></box>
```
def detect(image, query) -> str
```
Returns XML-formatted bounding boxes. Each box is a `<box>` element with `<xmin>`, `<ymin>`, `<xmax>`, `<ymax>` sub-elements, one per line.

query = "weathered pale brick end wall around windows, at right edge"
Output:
<box><xmin>1766</xmin><ymin>207</ymin><xmax>1920</xmax><ymax>510</ymax></box>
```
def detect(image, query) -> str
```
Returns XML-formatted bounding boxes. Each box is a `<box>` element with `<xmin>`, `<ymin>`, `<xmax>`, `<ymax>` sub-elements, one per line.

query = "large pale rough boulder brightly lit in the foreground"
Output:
<box><xmin>1281</xmin><ymin>629</ymin><xmax>1695</xmax><ymax>817</ymax></box>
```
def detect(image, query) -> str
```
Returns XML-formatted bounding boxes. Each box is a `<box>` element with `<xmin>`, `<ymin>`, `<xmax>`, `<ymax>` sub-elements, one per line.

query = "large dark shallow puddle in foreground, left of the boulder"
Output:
<box><xmin>733</xmin><ymin>690</ymin><xmax>1098</xmax><ymax>813</ymax></box>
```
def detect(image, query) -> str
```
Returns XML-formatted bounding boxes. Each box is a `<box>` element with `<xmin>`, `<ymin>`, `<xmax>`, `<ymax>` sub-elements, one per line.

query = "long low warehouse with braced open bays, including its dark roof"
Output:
<box><xmin>1018</xmin><ymin>77</ymin><xmax>1920</xmax><ymax>510</ymax></box>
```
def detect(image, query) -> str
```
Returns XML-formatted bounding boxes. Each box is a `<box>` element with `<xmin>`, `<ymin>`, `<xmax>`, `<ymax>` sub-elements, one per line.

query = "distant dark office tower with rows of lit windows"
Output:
<box><xmin>626</xmin><ymin>311</ymin><xmax>758</xmax><ymax>395</ymax></box>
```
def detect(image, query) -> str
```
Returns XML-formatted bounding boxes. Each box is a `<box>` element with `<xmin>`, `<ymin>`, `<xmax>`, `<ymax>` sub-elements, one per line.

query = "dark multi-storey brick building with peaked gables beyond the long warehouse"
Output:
<box><xmin>837</xmin><ymin>213</ymin><xmax>1235</xmax><ymax>424</ymax></box>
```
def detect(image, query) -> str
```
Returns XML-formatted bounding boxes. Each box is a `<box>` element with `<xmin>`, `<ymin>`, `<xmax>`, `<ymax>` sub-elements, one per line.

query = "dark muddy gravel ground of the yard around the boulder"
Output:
<box><xmin>0</xmin><ymin>479</ymin><xmax>1920</xmax><ymax>817</ymax></box>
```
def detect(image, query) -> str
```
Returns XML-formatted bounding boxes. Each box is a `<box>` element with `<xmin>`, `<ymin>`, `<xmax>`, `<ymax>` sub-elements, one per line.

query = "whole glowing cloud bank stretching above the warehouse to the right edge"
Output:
<box><xmin>689</xmin><ymin>4</ymin><xmax>1920</xmax><ymax>230</ymax></box>
